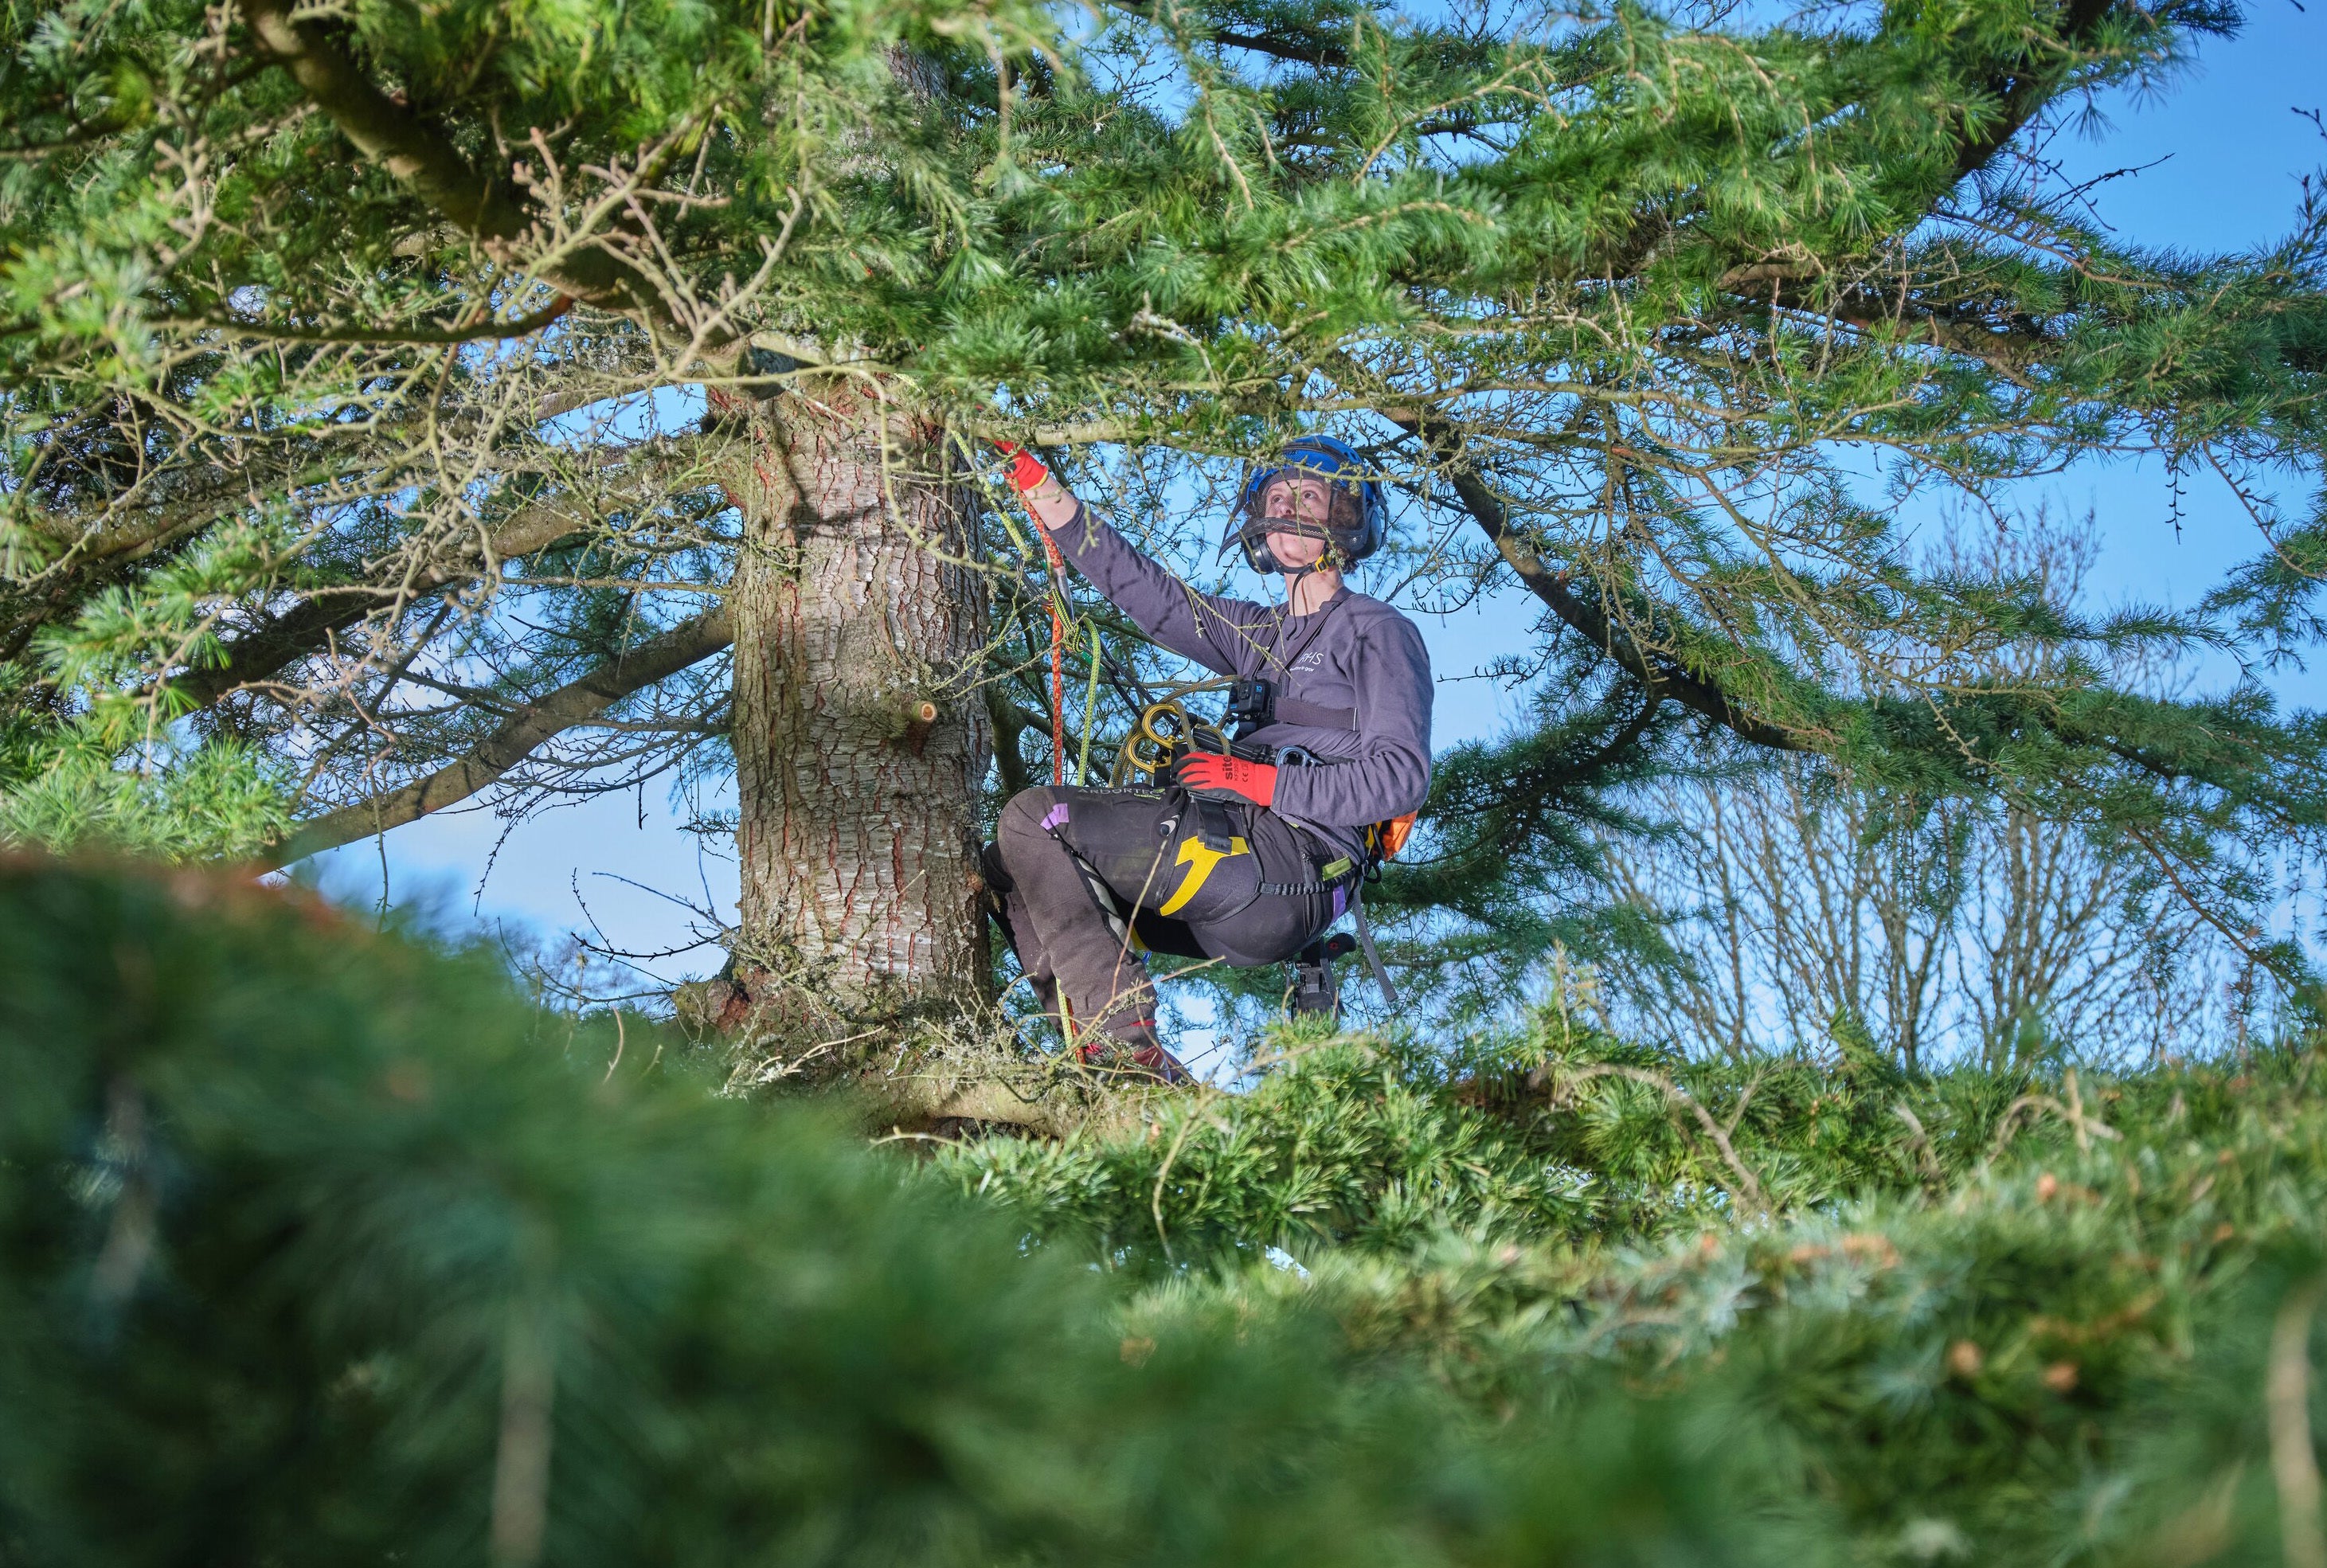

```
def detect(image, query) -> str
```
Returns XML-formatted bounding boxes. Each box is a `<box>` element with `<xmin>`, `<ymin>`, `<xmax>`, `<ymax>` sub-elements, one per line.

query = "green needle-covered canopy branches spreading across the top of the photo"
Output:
<box><xmin>0</xmin><ymin>0</ymin><xmax>2327</xmax><ymax>991</ymax></box>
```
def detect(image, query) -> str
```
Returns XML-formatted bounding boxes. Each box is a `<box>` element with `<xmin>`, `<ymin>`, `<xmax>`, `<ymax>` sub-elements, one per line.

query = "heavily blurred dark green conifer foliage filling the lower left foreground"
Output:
<box><xmin>0</xmin><ymin>863</ymin><xmax>1762</xmax><ymax>1568</ymax></box>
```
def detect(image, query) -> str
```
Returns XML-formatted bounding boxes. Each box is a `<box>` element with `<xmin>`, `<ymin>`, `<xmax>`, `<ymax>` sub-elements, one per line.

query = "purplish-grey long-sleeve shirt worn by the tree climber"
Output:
<box><xmin>1050</xmin><ymin>510</ymin><xmax>1431</xmax><ymax>854</ymax></box>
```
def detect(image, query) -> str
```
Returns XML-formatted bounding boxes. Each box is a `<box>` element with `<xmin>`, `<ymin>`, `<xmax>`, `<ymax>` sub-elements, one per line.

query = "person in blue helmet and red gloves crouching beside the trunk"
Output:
<box><xmin>984</xmin><ymin>437</ymin><xmax>1431</xmax><ymax>1080</ymax></box>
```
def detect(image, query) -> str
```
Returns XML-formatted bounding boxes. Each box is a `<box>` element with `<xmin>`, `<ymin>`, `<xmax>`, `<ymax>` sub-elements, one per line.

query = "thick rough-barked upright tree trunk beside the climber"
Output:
<box><xmin>729</xmin><ymin>386</ymin><xmax>989</xmax><ymax>1042</ymax></box>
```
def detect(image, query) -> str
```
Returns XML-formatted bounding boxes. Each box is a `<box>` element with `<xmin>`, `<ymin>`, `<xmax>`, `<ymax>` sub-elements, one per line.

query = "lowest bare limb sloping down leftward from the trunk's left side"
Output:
<box><xmin>268</xmin><ymin>607</ymin><xmax>735</xmax><ymax>866</ymax></box>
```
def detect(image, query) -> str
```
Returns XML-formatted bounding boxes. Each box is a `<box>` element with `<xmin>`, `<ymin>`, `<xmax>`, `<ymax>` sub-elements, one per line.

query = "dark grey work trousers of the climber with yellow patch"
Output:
<box><xmin>987</xmin><ymin>786</ymin><xmax>1347</xmax><ymax>1047</ymax></box>
